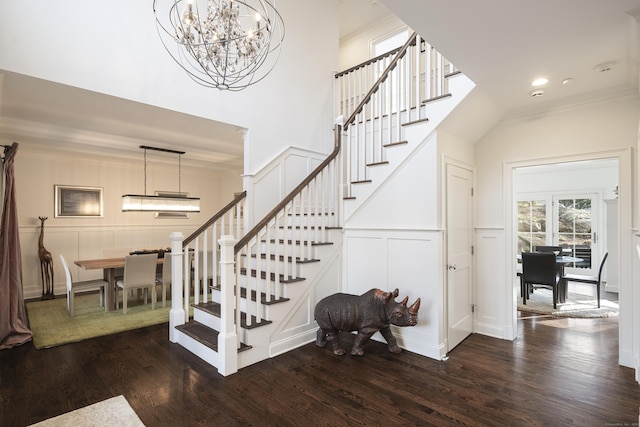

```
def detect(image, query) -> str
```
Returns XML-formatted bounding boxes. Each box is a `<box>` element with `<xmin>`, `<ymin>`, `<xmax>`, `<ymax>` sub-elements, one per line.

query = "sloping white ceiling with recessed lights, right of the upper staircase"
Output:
<box><xmin>380</xmin><ymin>0</ymin><xmax>640</xmax><ymax>115</ymax></box>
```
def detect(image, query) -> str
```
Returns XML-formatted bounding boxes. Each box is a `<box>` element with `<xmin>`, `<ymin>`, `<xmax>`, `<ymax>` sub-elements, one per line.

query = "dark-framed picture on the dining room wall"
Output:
<box><xmin>53</xmin><ymin>185</ymin><xmax>104</xmax><ymax>218</ymax></box>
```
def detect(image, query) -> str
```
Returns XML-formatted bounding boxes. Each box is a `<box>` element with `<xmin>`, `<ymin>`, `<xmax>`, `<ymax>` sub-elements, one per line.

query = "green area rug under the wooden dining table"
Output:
<box><xmin>26</xmin><ymin>293</ymin><xmax>171</xmax><ymax>349</ymax></box>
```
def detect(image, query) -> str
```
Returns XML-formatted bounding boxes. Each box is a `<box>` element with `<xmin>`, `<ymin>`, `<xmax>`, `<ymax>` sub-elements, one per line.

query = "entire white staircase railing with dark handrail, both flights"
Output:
<box><xmin>169</xmin><ymin>34</ymin><xmax>456</xmax><ymax>375</ymax></box>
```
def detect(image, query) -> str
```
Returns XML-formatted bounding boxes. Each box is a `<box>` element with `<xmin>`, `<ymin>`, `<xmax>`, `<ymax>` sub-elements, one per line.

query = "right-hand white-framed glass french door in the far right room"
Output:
<box><xmin>552</xmin><ymin>193</ymin><xmax>600</xmax><ymax>275</ymax></box>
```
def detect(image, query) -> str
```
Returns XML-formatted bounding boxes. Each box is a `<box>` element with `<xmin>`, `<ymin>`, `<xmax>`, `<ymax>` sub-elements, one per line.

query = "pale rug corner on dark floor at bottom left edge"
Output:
<box><xmin>33</xmin><ymin>396</ymin><xmax>144</xmax><ymax>427</ymax></box>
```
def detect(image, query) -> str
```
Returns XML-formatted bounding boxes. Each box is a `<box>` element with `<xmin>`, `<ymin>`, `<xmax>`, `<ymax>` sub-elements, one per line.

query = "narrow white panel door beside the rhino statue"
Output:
<box><xmin>446</xmin><ymin>164</ymin><xmax>473</xmax><ymax>351</ymax></box>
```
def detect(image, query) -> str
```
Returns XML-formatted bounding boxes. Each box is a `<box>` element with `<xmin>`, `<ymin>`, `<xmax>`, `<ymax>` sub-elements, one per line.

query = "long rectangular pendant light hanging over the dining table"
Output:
<box><xmin>122</xmin><ymin>145</ymin><xmax>200</xmax><ymax>212</ymax></box>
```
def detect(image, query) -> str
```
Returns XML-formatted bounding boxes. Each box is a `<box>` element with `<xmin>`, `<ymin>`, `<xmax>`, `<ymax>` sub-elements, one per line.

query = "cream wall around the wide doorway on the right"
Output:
<box><xmin>476</xmin><ymin>96</ymin><xmax>640</xmax><ymax>366</ymax></box>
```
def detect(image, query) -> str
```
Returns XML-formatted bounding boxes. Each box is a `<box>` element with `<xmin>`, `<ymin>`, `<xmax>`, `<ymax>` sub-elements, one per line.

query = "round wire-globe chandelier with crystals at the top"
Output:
<box><xmin>153</xmin><ymin>0</ymin><xmax>284</xmax><ymax>91</ymax></box>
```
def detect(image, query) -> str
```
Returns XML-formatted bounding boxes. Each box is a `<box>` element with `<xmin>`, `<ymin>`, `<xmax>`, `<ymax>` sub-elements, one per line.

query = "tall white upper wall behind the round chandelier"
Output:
<box><xmin>0</xmin><ymin>0</ymin><xmax>338</xmax><ymax>177</ymax></box>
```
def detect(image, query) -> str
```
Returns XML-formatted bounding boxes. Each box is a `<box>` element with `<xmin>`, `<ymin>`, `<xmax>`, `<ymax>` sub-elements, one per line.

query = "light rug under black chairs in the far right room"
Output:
<box><xmin>518</xmin><ymin>289</ymin><xmax>619</xmax><ymax>318</ymax></box>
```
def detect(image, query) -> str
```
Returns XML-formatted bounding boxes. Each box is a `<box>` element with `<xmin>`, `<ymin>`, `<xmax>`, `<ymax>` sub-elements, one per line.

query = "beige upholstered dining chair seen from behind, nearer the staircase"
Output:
<box><xmin>116</xmin><ymin>254</ymin><xmax>158</xmax><ymax>314</ymax></box>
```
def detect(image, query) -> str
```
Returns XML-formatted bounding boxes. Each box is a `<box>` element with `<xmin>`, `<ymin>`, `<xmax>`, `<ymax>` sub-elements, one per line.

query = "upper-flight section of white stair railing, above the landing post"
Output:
<box><xmin>335</xmin><ymin>33</ymin><xmax>456</xmax><ymax>197</ymax></box>
